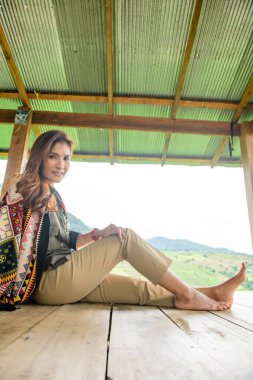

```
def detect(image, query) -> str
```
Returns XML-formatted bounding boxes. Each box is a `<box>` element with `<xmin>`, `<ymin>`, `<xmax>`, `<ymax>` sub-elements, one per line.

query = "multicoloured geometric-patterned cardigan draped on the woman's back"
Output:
<box><xmin>0</xmin><ymin>185</ymin><xmax>79</xmax><ymax>306</ymax></box>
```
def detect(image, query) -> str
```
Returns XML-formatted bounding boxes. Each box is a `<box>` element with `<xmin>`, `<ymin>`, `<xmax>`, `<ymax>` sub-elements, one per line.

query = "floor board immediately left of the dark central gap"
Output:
<box><xmin>0</xmin><ymin>304</ymin><xmax>110</xmax><ymax>380</ymax></box>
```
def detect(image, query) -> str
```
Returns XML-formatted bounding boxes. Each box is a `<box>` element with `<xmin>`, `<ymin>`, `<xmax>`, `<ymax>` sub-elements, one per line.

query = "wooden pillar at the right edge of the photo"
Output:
<box><xmin>241</xmin><ymin>122</ymin><xmax>253</xmax><ymax>252</ymax></box>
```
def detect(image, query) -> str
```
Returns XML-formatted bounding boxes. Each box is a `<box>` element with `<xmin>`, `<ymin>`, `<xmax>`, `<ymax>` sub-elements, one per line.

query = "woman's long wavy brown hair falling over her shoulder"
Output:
<box><xmin>17</xmin><ymin>131</ymin><xmax>73</xmax><ymax>210</ymax></box>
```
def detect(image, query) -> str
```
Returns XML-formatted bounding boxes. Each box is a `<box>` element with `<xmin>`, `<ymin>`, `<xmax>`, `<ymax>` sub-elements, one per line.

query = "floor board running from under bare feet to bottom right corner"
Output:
<box><xmin>164</xmin><ymin>309</ymin><xmax>253</xmax><ymax>380</ymax></box>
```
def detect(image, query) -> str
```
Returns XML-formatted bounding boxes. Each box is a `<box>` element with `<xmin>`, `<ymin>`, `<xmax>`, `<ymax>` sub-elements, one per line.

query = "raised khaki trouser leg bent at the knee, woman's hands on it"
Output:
<box><xmin>34</xmin><ymin>230</ymin><xmax>171</xmax><ymax>305</ymax></box>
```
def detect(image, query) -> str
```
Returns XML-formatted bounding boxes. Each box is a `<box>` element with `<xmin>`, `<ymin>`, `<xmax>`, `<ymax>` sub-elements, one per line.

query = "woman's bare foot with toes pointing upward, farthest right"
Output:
<box><xmin>197</xmin><ymin>263</ymin><xmax>246</xmax><ymax>306</ymax></box>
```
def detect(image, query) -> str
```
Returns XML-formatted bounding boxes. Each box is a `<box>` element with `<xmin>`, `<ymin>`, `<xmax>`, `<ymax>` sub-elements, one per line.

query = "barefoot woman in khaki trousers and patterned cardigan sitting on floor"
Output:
<box><xmin>0</xmin><ymin>131</ymin><xmax>246</xmax><ymax>310</ymax></box>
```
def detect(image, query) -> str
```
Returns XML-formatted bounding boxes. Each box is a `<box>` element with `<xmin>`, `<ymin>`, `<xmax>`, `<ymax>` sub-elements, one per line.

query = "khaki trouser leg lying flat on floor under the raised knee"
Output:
<box><xmin>81</xmin><ymin>273</ymin><xmax>175</xmax><ymax>307</ymax></box>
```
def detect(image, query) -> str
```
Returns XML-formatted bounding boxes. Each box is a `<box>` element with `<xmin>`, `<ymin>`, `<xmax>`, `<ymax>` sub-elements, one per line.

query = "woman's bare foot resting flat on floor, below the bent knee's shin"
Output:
<box><xmin>175</xmin><ymin>289</ymin><xmax>230</xmax><ymax>310</ymax></box>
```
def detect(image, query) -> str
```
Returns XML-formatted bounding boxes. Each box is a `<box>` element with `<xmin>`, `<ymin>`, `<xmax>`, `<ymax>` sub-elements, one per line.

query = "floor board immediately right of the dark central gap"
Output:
<box><xmin>108</xmin><ymin>307</ymin><xmax>231</xmax><ymax>380</ymax></box>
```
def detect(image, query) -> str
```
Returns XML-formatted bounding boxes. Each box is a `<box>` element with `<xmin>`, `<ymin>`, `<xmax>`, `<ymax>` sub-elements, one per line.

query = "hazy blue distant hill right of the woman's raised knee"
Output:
<box><xmin>146</xmin><ymin>236</ymin><xmax>242</xmax><ymax>253</ymax></box>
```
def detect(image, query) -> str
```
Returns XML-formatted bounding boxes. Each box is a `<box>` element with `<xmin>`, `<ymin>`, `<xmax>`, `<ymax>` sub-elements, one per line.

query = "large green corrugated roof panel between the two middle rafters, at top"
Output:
<box><xmin>114</xmin><ymin>0</ymin><xmax>194</xmax><ymax>97</ymax></box>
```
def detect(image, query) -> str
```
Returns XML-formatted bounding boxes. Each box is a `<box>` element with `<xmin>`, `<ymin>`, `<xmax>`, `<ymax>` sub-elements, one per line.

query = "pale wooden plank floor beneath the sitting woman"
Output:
<box><xmin>0</xmin><ymin>292</ymin><xmax>253</xmax><ymax>380</ymax></box>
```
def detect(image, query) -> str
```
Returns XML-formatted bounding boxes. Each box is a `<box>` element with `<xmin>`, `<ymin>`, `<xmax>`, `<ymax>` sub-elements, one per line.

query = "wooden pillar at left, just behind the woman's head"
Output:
<box><xmin>1</xmin><ymin>108</ymin><xmax>32</xmax><ymax>197</ymax></box>
